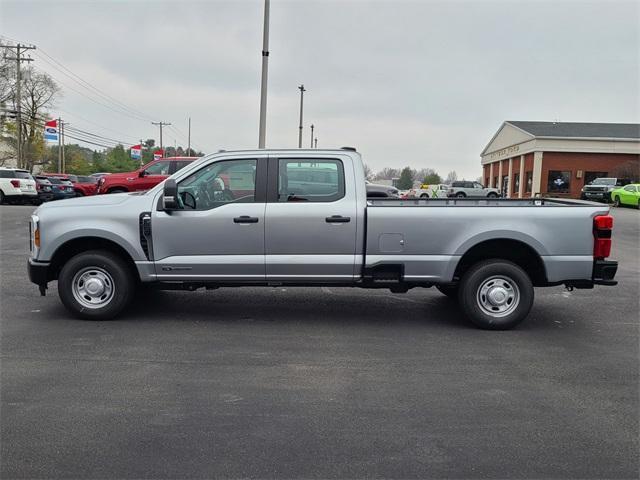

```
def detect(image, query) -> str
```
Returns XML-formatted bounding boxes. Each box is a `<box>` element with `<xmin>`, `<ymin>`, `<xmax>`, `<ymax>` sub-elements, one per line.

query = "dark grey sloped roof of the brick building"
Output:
<box><xmin>505</xmin><ymin>120</ymin><xmax>640</xmax><ymax>139</ymax></box>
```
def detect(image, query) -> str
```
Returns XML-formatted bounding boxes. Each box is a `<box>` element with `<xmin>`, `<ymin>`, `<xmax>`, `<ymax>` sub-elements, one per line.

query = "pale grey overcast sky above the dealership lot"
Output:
<box><xmin>0</xmin><ymin>0</ymin><xmax>640</xmax><ymax>179</ymax></box>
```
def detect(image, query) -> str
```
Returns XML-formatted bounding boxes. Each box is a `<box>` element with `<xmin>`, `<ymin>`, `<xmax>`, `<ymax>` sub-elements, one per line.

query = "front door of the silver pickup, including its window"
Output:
<box><xmin>151</xmin><ymin>157</ymin><xmax>267</xmax><ymax>282</ymax></box>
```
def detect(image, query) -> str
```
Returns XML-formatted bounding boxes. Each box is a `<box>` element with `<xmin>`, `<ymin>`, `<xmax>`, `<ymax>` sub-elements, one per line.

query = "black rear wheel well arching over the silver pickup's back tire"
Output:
<box><xmin>454</xmin><ymin>238</ymin><xmax>547</xmax><ymax>286</ymax></box>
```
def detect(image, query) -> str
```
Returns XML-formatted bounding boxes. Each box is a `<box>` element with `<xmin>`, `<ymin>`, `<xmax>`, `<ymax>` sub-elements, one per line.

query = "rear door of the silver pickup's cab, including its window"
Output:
<box><xmin>265</xmin><ymin>155</ymin><xmax>358</xmax><ymax>282</ymax></box>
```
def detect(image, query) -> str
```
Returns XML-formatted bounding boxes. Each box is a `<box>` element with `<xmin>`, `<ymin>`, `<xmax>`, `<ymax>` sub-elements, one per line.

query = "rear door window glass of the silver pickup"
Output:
<box><xmin>278</xmin><ymin>159</ymin><xmax>344</xmax><ymax>202</ymax></box>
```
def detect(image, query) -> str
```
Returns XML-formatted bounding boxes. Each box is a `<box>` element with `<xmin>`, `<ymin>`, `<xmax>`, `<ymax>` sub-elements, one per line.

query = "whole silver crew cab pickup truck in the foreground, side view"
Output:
<box><xmin>28</xmin><ymin>149</ymin><xmax>617</xmax><ymax>329</ymax></box>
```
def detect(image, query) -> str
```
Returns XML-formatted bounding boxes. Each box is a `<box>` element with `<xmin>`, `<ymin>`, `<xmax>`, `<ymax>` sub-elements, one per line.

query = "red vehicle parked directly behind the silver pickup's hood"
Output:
<box><xmin>98</xmin><ymin>157</ymin><xmax>198</xmax><ymax>194</ymax></box>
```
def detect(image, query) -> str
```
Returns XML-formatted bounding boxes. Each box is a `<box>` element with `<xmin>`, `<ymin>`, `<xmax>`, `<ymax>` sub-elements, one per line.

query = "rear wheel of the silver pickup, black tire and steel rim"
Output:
<box><xmin>458</xmin><ymin>259</ymin><xmax>534</xmax><ymax>330</ymax></box>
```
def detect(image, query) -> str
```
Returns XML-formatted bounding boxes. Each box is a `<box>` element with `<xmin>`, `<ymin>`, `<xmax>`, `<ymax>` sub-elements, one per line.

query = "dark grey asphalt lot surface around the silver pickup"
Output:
<box><xmin>0</xmin><ymin>206</ymin><xmax>640</xmax><ymax>479</ymax></box>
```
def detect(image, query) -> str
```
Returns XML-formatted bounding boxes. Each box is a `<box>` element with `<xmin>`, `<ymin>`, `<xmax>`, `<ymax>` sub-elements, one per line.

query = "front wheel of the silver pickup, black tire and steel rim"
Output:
<box><xmin>58</xmin><ymin>250</ymin><xmax>136</xmax><ymax>320</ymax></box>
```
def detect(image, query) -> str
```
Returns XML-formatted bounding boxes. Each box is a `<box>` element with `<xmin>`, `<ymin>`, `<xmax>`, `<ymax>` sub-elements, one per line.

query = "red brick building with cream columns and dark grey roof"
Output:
<box><xmin>480</xmin><ymin>121</ymin><xmax>640</xmax><ymax>198</ymax></box>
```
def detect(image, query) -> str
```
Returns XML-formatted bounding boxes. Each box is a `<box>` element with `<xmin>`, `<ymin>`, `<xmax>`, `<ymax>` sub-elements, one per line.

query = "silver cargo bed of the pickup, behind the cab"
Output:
<box><xmin>365</xmin><ymin>198</ymin><xmax>609</xmax><ymax>283</ymax></box>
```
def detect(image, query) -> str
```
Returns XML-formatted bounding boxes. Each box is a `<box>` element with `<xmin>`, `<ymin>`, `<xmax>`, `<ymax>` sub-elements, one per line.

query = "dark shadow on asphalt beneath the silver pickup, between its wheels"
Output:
<box><xmin>121</xmin><ymin>287</ymin><xmax>474</xmax><ymax>329</ymax></box>
